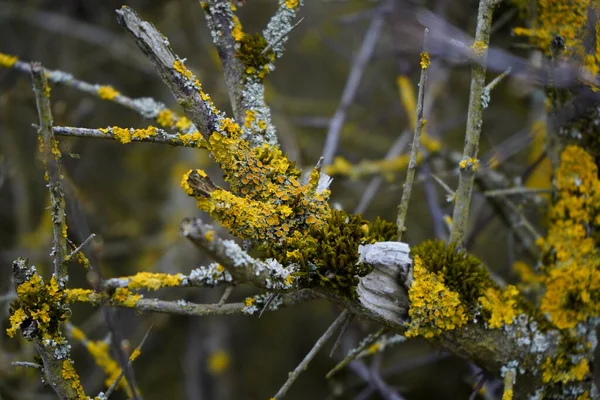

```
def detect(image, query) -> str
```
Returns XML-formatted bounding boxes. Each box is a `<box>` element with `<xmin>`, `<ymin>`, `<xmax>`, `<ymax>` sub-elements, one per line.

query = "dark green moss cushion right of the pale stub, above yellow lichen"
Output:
<box><xmin>411</xmin><ymin>240</ymin><xmax>495</xmax><ymax>307</ymax></box>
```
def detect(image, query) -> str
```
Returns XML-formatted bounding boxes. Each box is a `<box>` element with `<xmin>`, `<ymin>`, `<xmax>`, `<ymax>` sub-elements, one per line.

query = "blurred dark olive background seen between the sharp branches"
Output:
<box><xmin>0</xmin><ymin>0</ymin><xmax>548</xmax><ymax>400</ymax></box>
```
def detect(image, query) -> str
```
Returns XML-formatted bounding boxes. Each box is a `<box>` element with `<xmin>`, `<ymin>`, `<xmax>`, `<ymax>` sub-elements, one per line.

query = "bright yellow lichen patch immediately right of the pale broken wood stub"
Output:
<box><xmin>405</xmin><ymin>256</ymin><xmax>467</xmax><ymax>338</ymax></box>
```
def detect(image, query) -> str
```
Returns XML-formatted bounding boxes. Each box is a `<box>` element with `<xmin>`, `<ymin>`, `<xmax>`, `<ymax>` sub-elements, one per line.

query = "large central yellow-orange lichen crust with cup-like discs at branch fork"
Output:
<box><xmin>190</xmin><ymin>131</ymin><xmax>329</xmax><ymax>241</ymax></box>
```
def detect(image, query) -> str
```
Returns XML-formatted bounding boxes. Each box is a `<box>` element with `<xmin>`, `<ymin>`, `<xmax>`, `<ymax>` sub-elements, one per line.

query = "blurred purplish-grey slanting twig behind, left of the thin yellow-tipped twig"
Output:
<box><xmin>323</xmin><ymin>6</ymin><xmax>383</xmax><ymax>165</ymax></box>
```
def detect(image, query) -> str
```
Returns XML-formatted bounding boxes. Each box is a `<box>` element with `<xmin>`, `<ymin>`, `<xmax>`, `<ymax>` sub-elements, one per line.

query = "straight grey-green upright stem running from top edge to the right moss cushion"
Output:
<box><xmin>450</xmin><ymin>0</ymin><xmax>499</xmax><ymax>246</ymax></box>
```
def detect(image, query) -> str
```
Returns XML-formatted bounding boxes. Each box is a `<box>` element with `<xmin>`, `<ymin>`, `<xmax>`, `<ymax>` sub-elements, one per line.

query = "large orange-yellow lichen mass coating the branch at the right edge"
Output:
<box><xmin>538</xmin><ymin>146</ymin><xmax>600</xmax><ymax>329</ymax></box>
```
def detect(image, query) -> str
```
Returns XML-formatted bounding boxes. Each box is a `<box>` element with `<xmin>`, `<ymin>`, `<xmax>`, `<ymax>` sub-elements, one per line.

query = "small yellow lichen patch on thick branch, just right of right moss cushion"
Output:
<box><xmin>479</xmin><ymin>285</ymin><xmax>519</xmax><ymax>329</ymax></box>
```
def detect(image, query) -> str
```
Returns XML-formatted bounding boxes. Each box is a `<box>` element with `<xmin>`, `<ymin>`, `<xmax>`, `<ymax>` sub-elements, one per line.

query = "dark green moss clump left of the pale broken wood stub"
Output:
<box><xmin>263</xmin><ymin>210</ymin><xmax>397</xmax><ymax>298</ymax></box>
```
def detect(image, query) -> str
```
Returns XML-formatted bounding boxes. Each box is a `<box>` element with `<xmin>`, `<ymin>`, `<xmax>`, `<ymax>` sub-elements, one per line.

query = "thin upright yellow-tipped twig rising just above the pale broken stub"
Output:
<box><xmin>396</xmin><ymin>28</ymin><xmax>429</xmax><ymax>242</ymax></box>
